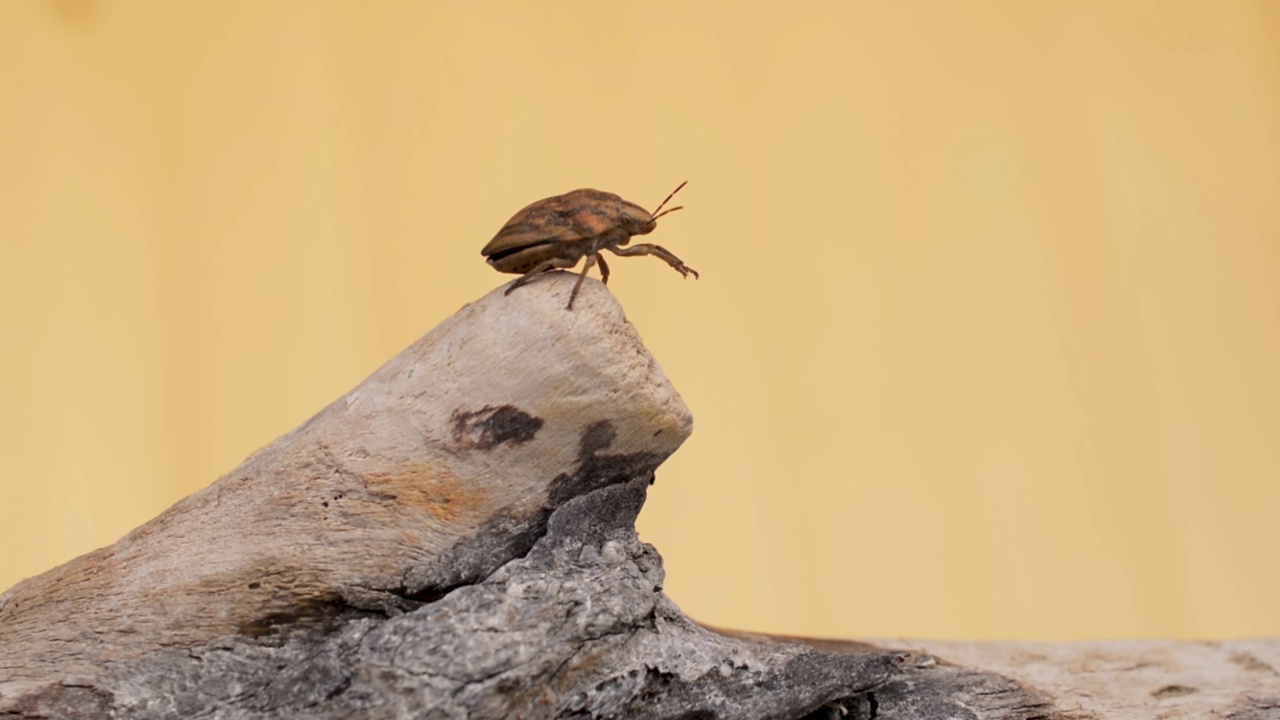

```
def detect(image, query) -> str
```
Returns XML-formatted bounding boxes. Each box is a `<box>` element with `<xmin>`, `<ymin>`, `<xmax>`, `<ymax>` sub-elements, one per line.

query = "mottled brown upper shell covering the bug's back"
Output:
<box><xmin>480</xmin><ymin>188</ymin><xmax>623</xmax><ymax>258</ymax></box>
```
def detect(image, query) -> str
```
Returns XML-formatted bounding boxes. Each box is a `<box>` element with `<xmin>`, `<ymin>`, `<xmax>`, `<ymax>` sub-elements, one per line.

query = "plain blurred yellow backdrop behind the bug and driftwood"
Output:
<box><xmin>0</xmin><ymin>0</ymin><xmax>1280</xmax><ymax>639</ymax></box>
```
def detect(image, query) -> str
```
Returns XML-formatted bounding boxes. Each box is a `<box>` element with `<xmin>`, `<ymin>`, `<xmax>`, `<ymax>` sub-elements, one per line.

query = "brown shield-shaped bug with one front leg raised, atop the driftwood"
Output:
<box><xmin>480</xmin><ymin>181</ymin><xmax>698</xmax><ymax>310</ymax></box>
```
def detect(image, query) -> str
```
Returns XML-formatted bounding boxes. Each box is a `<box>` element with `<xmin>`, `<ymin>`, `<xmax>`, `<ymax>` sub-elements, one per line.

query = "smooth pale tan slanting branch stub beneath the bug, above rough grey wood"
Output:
<box><xmin>0</xmin><ymin>273</ymin><xmax>692</xmax><ymax>697</ymax></box>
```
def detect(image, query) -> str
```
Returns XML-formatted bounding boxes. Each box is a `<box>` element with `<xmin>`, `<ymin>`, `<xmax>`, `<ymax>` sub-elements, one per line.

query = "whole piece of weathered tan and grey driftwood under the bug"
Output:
<box><xmin>0</xmin><ymin>273</ymin><xmax>1280</xmax><ymax>719</ymax></box>
